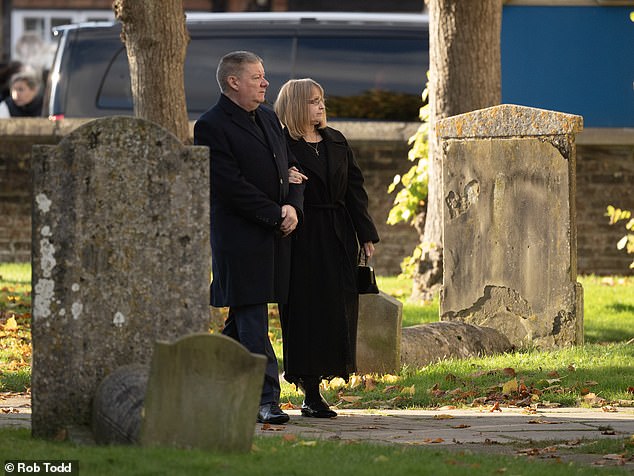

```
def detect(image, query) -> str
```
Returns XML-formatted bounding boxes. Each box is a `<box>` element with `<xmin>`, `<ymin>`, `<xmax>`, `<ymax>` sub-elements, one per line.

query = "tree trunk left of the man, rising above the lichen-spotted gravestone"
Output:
<box><xmin>112</xmin><ymin>0</ymin><xmax>189</xmax><ymax>142</ymax></box>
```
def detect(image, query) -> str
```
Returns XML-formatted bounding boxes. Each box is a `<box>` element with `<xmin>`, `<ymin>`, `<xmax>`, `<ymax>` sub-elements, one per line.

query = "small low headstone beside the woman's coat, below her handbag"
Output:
<box><xmin>357</xmin><ymin>292</ymin><xmax>403</xmax><ymax>373</ymax></box>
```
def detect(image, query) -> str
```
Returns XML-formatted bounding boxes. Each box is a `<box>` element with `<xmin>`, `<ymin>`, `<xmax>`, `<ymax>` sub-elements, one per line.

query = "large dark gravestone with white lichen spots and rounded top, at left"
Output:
<box><xmin>32</xmin><ymin>117</ymin><xmax>210</xmax><ymax>437</ymax></box>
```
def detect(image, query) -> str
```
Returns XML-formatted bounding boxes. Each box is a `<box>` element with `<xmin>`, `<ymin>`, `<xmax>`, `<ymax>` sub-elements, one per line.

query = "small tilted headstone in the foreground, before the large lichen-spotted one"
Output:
<box><xmin>141</xmin><ymin>334</ymin><xmax>266</xmax><ymax>452</ymax></box>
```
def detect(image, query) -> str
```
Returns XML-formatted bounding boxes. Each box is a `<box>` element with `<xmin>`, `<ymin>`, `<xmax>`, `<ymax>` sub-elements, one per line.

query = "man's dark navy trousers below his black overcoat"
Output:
<box><xmin>222</xmin><ymin>303</ymin><xmax>280</xmax><ymax>405</ymax></box>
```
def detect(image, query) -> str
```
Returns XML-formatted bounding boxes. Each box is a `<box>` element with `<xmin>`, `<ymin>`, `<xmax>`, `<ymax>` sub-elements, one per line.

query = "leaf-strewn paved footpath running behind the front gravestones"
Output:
<box><xmin>0</xmin><ymin>394</ymin><xmax>634</xmax><ymax>471</ymax></box>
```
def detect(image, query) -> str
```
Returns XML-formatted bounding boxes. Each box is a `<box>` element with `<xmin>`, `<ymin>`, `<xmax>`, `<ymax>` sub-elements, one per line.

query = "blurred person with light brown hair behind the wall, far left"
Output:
<box><xmin>0</xmin><ymin>70</ymin><xmax>43</xmax><ymax>118</ymax></box>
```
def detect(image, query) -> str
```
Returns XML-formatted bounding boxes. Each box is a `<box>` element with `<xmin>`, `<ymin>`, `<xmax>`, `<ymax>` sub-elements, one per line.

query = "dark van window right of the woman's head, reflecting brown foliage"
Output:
<box><xmin>296</xmin><ymin>37</ymin><xmax>429</xmax><ymax>121</ymax></box>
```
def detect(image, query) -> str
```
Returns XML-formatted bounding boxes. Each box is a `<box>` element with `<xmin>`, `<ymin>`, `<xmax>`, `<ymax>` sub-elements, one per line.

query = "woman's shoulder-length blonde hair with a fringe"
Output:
<box><xmin>274</xmin><ymin>78</ymin><xmax>327</xmax><ymax>140</ymax></box>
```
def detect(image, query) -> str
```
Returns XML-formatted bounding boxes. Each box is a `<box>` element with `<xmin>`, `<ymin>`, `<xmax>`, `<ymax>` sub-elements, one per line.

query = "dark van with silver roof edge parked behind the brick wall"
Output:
<box><xmin>45</xmin><ymin>12</ymin><xmax>429</xmax><ymax>121</ymax></box>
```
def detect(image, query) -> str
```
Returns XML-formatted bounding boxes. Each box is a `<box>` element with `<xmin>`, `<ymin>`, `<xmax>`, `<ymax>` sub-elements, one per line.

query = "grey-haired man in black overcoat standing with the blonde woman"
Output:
<box><xmin>194</xmin><ymin>51</ymin><xmax>303</xmax><ymax>424</ymax></box>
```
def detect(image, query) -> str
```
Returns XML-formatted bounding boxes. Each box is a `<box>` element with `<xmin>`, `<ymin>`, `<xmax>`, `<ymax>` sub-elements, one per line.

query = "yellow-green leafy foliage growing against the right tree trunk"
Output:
<box><xmin>387</xmin><ymin>83</ymin><xmax>429</xmax><ymax>225</ymax></box>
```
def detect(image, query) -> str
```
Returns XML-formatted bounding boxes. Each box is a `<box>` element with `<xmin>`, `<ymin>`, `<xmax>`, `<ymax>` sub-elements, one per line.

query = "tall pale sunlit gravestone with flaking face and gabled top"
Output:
<box><xmin>436</xmin><ymin>105</ymin><xmax>583</xmax><ymax>348</ymax></box>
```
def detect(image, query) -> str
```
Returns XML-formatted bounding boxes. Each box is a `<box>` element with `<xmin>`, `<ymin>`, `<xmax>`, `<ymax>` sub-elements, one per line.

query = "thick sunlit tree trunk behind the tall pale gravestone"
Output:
<box><xmin>412</xmin><ymin>0</ymin><xmax>502</xmax><ymax>300</ymax></box>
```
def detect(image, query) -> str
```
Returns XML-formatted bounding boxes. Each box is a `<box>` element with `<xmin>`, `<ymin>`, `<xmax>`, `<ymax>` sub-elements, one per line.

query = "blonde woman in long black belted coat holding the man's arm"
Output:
<box><xmin>275</xmin><ymin>79</ymin><xmax>379</xmax><ymax>418</ymax></box>
